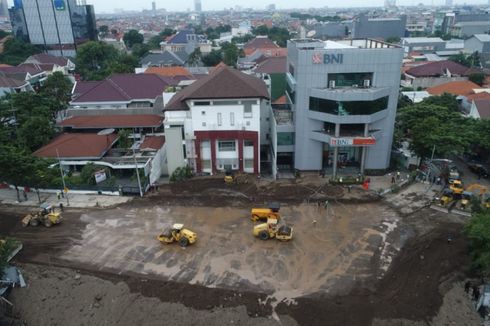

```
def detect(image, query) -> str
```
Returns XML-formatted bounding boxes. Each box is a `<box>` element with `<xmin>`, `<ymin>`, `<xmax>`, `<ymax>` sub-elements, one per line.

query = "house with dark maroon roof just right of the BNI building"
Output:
<box><xmin>401</xmin><ymin>60</ymin><xmax>471</xmax><ymax>90</ymax></box>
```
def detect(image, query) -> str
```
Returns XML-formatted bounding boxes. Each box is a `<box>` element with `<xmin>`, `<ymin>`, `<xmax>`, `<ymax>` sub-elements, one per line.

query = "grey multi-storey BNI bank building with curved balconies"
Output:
<box><xmin>286</xmin><ymin>39</ymin><xmax>403</xmax><ymax>177</ymax></box>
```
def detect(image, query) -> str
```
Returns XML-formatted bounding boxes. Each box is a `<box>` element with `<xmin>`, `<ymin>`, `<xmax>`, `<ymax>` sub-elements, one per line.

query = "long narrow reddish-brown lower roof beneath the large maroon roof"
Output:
<box><xmin>58</xmin><ymin>114</ymin><xmax>163</xmax><ymax>129</ymax></box>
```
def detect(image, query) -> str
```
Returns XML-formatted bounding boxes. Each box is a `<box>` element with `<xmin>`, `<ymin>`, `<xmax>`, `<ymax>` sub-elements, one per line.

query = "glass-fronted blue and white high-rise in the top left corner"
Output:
<box><xmin>10</xmin><ymin>0</ymin><xmax>97</xmax><ymax>56</ymax></box>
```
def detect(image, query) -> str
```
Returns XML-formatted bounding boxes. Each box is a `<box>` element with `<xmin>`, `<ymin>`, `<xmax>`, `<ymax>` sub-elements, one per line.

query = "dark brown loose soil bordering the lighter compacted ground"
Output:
<box><xmin>0</xmin><ymin>183</ymin><xmax>474</xmax><ymax>325</ymax></box>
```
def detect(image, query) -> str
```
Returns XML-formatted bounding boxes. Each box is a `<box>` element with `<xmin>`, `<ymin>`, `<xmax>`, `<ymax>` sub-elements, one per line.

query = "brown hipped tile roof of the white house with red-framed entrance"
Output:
<box><xmin>164</xmin><ymin>66</ymin><xmax>270</xmax><ymax>111</ymax></box>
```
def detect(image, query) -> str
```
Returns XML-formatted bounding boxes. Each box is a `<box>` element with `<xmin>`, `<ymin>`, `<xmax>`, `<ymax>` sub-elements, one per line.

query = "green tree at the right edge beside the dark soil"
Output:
<box><xmin>464</xmin><ymin>209</ymin><xmax>490</xmax><ymax>276</ymax></box>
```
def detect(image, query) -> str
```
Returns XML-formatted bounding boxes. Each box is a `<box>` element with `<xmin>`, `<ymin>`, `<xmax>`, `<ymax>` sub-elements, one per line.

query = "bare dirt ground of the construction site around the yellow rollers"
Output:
<box><xmin>0</xmin><ymin>179</ymin><xmax>482</xmax><ymax>325</ymax></box>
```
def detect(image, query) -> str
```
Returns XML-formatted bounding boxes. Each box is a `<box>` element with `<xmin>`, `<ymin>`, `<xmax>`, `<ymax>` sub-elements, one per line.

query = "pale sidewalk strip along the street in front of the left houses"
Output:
<box><xmin>0</xmin><ymin>189</ymin><xmax>133</xmax><ymax>208</ymax></box>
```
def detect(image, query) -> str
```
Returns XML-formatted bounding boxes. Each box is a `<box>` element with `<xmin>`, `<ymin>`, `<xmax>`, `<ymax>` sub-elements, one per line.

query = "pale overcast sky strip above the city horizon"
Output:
<box><xmin>82</xmin><ymin>0</ymin><xmax>488</xmax><ymax>13</ymax></box>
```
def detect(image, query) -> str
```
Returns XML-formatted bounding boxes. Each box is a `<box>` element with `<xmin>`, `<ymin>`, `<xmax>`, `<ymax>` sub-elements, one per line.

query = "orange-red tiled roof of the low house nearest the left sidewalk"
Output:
<box><xmin>33</xmin><ymin>133</ymin><xmax>117</xmax><ymax>159</ymax></box>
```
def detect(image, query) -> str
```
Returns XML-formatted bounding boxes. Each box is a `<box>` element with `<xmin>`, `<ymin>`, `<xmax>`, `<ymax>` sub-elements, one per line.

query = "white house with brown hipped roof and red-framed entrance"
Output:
<box><xmin>164</xmin><ymin>65</ymin><xmax>271</xmax><ymax>174</ymax></box>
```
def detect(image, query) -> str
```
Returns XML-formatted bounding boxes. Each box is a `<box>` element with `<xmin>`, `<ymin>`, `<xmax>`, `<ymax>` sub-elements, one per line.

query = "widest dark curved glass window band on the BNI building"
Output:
<box><xmin>310</xmin><ymin>96</ymin><xmax>388</xmax><ymax>116</ymax></box>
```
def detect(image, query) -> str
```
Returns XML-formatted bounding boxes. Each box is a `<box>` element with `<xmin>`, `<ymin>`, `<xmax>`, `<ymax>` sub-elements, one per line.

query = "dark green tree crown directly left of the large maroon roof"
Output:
<box><xmin>39</xmin><ymin>71</ymin><xmax>73</xmax><ymax>111</ymax></box>
